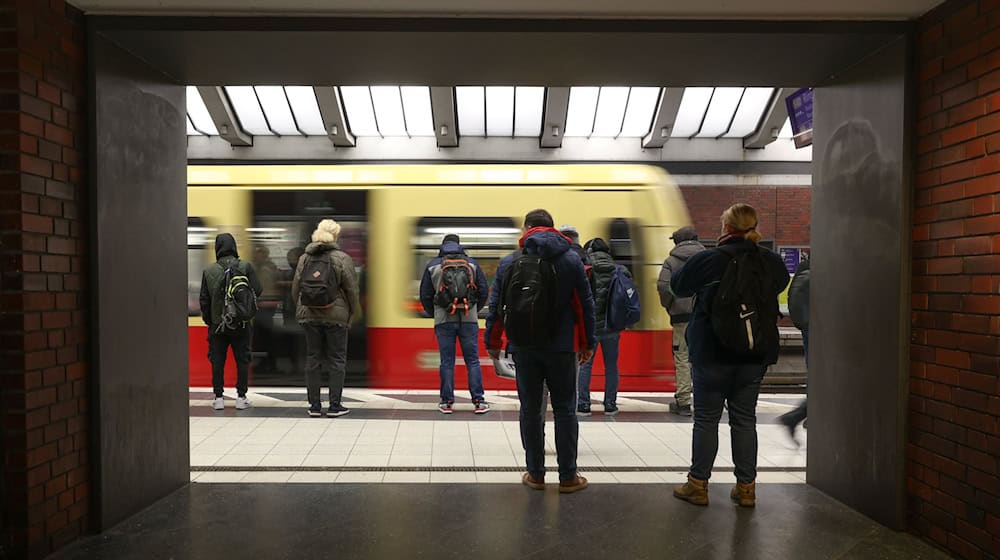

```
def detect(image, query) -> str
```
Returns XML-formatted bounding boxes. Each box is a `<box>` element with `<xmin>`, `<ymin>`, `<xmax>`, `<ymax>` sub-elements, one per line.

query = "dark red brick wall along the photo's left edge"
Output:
<box><xmin>0</xmin><ymin>0</ymin><xmax>90</xmax><ymax>558</ymax></box>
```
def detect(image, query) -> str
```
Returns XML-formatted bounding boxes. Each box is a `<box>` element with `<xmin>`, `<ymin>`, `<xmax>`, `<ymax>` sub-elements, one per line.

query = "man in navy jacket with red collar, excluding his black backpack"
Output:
<box><xmin>486</xmin><ymin>209</ymin><xmax>597</xmax><ymax>493</ymax></box>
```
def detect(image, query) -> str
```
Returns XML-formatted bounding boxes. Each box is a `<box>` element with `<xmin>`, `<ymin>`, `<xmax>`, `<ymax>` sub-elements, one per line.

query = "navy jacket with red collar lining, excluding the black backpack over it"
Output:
<box><xmin>486</xmin><ymin>228</ymin><xmax>597</xmax><ymax>352</ymax></box>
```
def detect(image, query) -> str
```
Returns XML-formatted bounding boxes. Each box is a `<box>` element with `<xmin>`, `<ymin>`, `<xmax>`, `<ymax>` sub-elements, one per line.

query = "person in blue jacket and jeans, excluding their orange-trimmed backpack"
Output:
<box><xmin>420</xmin><ymin>233</ymin><xmax>490</xmax><ymax>414</ymax></box>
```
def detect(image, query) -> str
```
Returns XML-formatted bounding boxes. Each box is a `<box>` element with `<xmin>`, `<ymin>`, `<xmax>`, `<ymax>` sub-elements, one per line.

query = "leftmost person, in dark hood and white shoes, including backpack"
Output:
<box><xmin>199</xmin><ymin>233</ymin><xmax>261</xmax><ymax>410</ymax></box>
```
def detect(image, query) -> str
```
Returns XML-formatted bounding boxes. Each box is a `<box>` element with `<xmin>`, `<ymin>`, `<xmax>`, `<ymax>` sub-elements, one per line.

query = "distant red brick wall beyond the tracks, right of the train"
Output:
<box><xmin>681</xmin><ymin>186</ymin><xmax>812</xmax><ymax>245</ymax></box>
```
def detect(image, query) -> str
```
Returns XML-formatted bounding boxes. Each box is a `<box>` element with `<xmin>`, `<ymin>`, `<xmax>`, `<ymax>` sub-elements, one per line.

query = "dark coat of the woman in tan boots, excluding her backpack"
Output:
<box><xmin>670</xmin><ymin>237</ymin><xmax>788</xmax><ymax>367</ymax></box>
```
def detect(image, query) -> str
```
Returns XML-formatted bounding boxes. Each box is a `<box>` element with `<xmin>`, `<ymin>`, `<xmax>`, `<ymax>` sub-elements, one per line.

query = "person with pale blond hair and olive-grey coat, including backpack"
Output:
<box><xmin>292</xmin><ymin>219</ymin><xmax>361</xmax><ymax>417</ymax></box>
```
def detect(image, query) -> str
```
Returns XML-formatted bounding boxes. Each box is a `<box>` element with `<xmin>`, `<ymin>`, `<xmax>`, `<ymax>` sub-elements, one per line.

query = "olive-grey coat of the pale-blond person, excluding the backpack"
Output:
<box><xmin>292</xmin><ymin>243</ymin><xmax>361</xmax><ymax>327</ymax></box>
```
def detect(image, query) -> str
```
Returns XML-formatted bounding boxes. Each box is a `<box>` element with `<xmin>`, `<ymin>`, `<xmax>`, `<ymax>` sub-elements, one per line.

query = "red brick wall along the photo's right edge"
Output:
<box><xmin>907</xmin><ymin>0</ymin><xmax>1000</xmax><ymax>558</ymax></box>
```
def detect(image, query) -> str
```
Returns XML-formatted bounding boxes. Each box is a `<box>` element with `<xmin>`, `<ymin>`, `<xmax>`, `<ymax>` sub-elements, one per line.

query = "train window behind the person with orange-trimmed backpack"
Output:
<box><xmin>414</xmin><ymin>217</ymin><xmax>521</xmax><ymax>317</ymax></box>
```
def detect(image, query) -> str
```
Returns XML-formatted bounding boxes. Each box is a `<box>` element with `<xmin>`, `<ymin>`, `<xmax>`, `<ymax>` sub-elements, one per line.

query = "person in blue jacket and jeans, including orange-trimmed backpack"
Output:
<box><xmin>420</xmin><ymin>233</ymin><xmax>490</xmax><ymax>414</ymax></box>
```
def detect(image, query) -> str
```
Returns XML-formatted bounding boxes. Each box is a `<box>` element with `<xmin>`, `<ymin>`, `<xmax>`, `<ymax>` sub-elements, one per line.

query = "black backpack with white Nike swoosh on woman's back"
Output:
<box><xmin>709</xmin><ymin>246</ymin><xmax>778</xmax><ymax>359</ymax></box>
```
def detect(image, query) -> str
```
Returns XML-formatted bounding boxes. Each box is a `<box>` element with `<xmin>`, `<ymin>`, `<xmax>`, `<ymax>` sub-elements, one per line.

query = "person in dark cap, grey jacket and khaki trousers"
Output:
<box><xmin>656</xmin><ymin>226</ymin><xmax>705</xmax><ymax>416</ymax></box>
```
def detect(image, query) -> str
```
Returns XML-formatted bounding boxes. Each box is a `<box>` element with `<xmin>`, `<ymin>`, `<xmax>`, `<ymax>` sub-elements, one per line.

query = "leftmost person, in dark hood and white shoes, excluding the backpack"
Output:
<box><xmin>199</xmin><ymin>233</ymin><xmax>262</xmax><ymax>410</ymax></box>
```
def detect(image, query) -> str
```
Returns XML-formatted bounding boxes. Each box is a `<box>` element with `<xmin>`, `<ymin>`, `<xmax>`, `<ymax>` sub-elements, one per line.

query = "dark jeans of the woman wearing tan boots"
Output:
<box><xmin>691</xmin><ymin>364</ymin><xmax>767</xmax><ymax>483</ymax></box>
